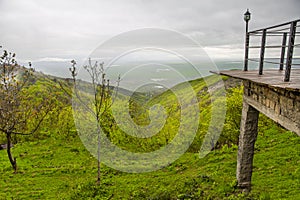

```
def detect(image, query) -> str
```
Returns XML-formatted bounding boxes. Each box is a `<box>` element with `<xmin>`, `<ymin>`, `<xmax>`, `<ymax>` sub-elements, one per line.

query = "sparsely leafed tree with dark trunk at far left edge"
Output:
<box><xmin>0</xmin><ymin>50</ymin><xmax>52</xmax><ymax>172</ymax></box>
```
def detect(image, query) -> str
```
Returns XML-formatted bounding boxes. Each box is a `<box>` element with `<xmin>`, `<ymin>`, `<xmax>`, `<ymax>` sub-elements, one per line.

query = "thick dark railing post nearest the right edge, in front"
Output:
<box><xmin>284</xmin><ymin>21</ymin><xmax>297</xmax><ymax>82</ymax></box>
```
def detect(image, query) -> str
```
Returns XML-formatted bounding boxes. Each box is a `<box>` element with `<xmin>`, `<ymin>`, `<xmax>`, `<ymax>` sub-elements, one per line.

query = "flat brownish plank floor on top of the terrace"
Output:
<box><xmin>212</xmin><ymin>69</ymin><xmax>300</xmax><ymax>92</ymax></box>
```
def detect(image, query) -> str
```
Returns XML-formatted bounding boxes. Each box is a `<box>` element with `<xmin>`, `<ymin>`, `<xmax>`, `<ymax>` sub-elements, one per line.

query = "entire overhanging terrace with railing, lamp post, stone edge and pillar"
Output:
<box><xmin>215</xmin><ymin>17</ymin><xmax>300</xmax><ymax>191</ymax></box>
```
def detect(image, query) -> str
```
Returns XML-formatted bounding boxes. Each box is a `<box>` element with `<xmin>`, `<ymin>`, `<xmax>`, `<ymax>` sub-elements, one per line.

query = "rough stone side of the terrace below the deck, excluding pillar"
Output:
<box><xmin>244</xmin><ymin>80</ymin><xmax>300</xmax><ymax>135</ymax></box>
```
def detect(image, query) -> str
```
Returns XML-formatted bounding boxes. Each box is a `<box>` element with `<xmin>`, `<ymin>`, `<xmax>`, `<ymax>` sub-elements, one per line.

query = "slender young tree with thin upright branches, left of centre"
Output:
<box><xmin>69</xmin><ymin>59</ymin><xmax>120</xmax><ymax>184</ymax></box>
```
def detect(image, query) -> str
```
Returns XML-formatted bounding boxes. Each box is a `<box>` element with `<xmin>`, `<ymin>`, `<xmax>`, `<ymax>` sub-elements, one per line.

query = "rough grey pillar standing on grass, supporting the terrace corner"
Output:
<box><xmin>236</xmin><ymin>100</ymin><xmax>259</xmax><ymax>192</ymax></box>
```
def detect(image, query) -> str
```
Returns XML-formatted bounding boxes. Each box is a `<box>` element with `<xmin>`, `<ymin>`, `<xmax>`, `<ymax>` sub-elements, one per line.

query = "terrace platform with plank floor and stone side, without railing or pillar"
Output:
<box><xmin>218</xmin><ymin>69</ymin><xmax>300</xmax><ymax>136</ymax></box>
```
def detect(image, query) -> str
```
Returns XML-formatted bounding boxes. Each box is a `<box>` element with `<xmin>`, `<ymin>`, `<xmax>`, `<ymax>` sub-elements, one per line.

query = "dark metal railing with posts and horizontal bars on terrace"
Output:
<box><xmin>244</xmin><ymin>19</ymin><xmax>300</xmax><ymax>82</ymax></box>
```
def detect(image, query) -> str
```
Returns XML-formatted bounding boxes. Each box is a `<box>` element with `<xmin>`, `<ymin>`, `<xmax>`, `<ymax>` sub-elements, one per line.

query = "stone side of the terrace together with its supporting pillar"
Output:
<box><xmin>236</xmin><ymin>80</ymin><xmax>300</xmax><ymax>191</ymax></box>
